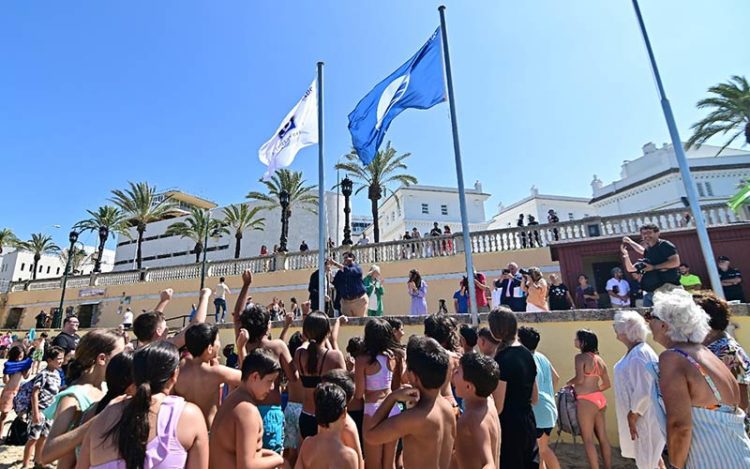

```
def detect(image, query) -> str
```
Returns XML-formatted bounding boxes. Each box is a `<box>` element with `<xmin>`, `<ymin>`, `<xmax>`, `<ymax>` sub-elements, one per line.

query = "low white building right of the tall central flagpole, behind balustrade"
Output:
<box><xmin>488</xmin><ymin>186</ymin><xmax>596</xmax><ymax>230</ymax></box>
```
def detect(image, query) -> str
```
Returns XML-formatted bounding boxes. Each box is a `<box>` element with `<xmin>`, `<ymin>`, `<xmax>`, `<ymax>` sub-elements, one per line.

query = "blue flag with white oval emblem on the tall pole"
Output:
<box><xmin>349</xmin><ymin>28</ymin><xmax>446</xmax><ymax>165</ymax></box>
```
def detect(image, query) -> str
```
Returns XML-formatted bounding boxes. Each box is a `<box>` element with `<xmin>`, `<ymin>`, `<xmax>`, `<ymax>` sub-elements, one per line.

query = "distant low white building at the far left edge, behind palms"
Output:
<box><xmin>0</xmin><ymin>246</ymin><xmax>115</xmax><ymax>291</ymax></box>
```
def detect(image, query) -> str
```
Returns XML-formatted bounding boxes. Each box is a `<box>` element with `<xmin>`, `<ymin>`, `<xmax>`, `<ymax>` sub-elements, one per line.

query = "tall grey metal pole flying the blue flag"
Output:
<box><xmin>438</xmin><ymin>5</ymin><xmax>479</xmax><ymax>326</ymax></box>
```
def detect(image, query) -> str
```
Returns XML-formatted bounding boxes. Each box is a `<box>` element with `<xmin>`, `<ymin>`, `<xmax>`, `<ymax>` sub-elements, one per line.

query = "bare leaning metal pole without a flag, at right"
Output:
<box><xmin>633</xmin><ymin>0</ymin><xmax>724</xmax><ymax>298</ymax></box>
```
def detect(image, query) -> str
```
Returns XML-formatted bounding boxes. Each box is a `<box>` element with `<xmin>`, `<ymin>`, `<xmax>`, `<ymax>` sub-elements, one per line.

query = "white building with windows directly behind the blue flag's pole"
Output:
<box><xmin>364</xmin><ymin>181</ymin><xmax>490</xmax><ymax>242</ymax></box>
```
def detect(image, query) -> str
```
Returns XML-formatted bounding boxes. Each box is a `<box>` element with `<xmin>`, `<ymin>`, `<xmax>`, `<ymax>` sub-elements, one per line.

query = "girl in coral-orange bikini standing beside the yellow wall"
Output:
<box><xmin>567</xmin><ymin>329</ymin><xmax>612</xmax><ymax>469</ymax></box>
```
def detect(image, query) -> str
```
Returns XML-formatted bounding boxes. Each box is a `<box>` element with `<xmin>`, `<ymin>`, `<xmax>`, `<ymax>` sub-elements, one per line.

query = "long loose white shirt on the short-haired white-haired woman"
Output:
<box><xmin>614</xmin><ymin>343</ymin><xmax>666</xmax><ymax>468</ymax></box>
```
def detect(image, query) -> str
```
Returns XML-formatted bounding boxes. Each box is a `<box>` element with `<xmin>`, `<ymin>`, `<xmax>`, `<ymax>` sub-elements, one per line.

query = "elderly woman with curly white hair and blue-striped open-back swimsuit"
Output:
<box><xmin>647</xmin><ymin>290</ymin><xmax>750</xmax><ymax>468</ymax></box>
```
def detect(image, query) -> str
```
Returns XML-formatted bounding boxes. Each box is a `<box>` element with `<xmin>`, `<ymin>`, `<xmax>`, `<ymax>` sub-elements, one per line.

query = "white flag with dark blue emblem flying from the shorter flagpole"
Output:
<box><xmin>258</xmin><ymin>79</ymin><xmax>318</xmax><ymax>181</ymax></box>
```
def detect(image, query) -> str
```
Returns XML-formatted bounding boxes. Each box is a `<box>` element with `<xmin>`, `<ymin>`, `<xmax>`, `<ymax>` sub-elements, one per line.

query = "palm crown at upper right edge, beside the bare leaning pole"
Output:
<box><xmin>685</xmin><ymin>75</ymin><xmax>750</xmax><ymax>156</ymax></box>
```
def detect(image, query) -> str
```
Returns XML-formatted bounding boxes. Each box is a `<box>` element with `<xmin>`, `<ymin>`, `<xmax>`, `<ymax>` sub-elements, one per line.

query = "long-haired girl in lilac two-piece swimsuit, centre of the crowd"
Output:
<box><xmin>354</xmin><ymin>318</ymin><xmax>402</xmax><ymax>469</ymax></box>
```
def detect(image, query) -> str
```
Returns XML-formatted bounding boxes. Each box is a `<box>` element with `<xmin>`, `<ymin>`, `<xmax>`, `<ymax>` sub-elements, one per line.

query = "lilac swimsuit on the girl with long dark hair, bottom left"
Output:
<box><xmin>91</xmin><ymin>396</ymin><xmax>187</xmax><ymax>469</ymax></box>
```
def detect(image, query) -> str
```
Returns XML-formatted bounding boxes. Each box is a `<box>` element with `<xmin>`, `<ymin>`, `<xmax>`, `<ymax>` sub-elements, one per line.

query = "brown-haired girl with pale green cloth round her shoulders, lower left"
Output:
<box><xmin>44</xmin><ymin>330</ymin><xmax>125</xmax><ymax>469</ymax></box>
